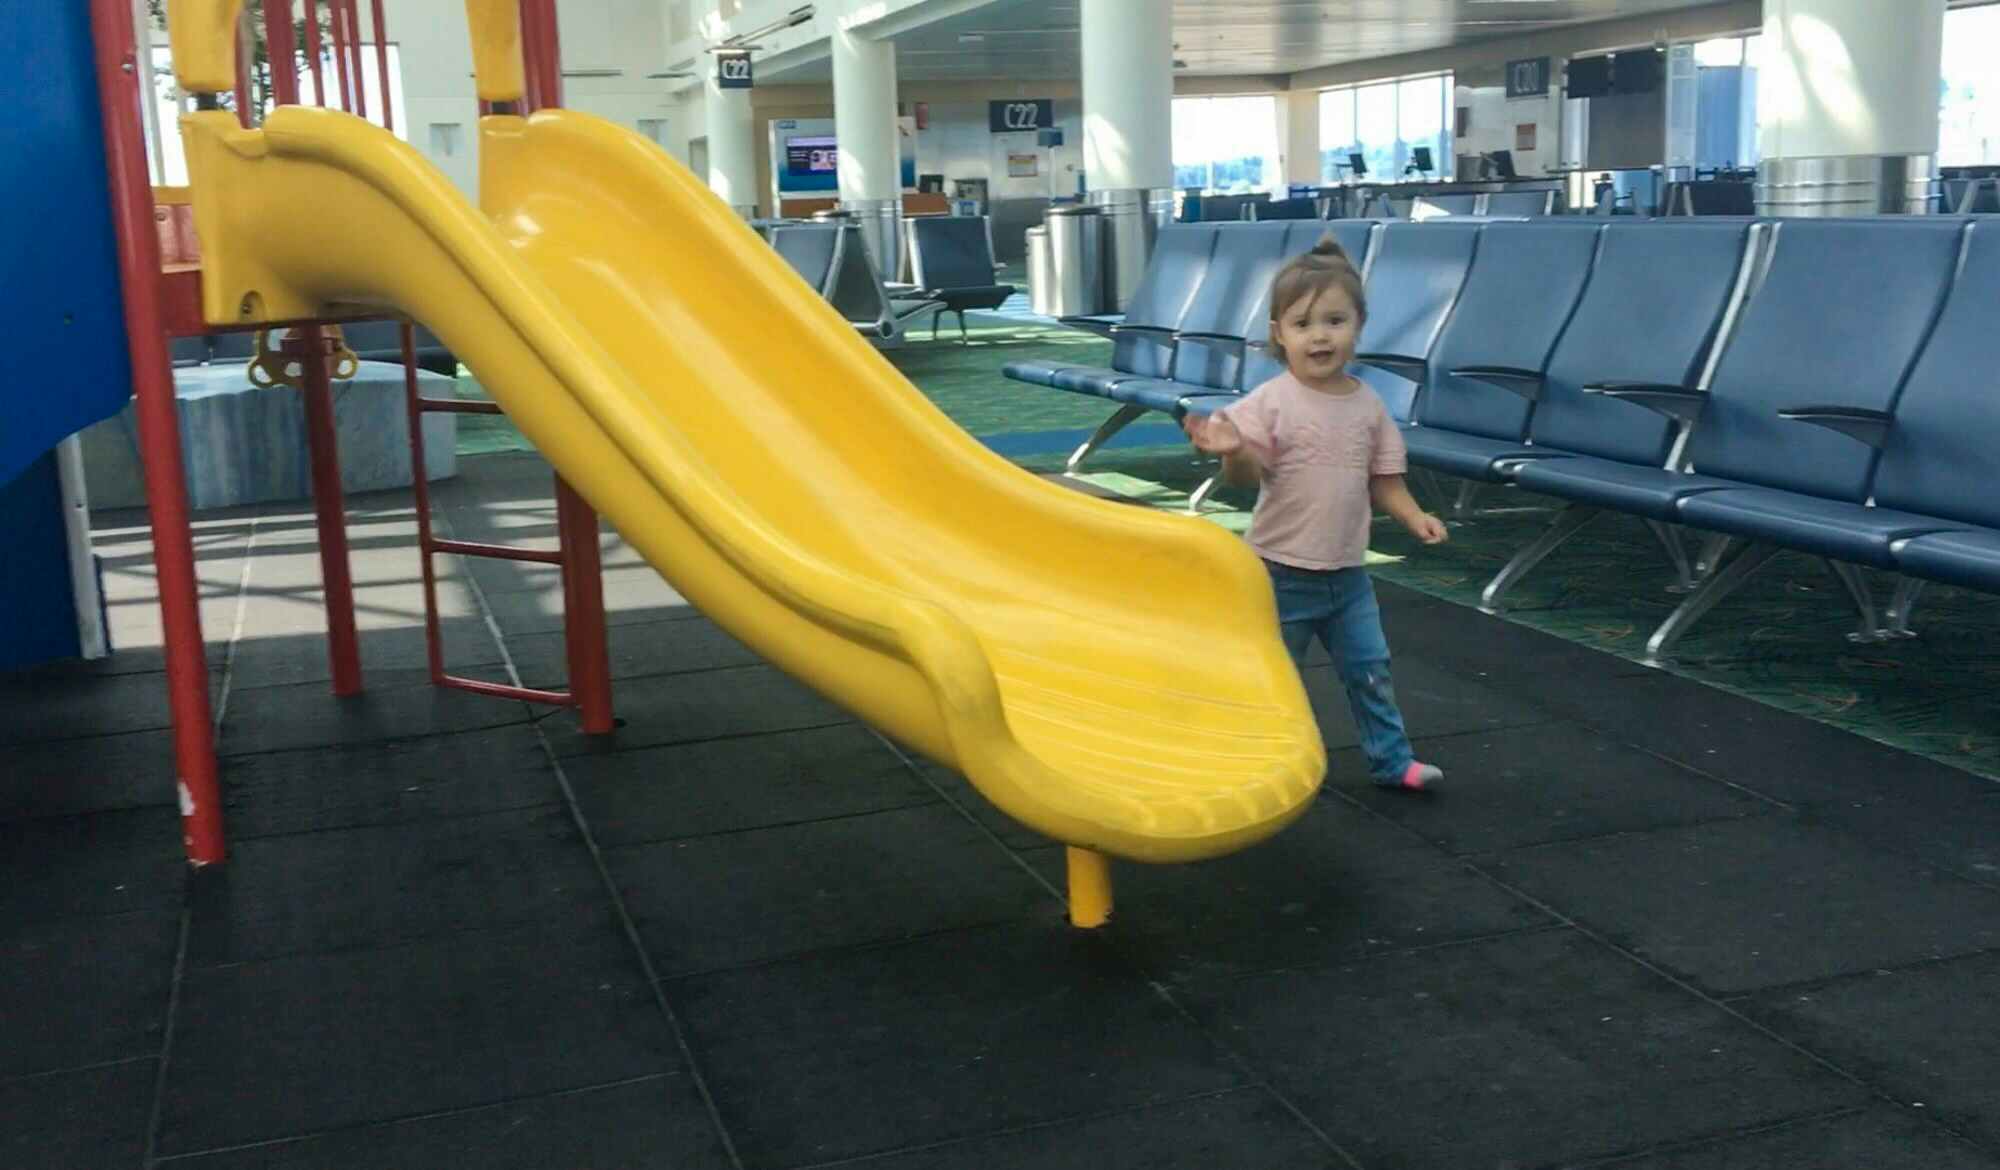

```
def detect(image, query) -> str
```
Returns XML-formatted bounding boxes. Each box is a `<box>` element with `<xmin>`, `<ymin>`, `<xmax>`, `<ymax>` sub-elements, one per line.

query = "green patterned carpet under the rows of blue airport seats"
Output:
<box><xmin>458</xmin><ymin>316</ymin><xmax>2000</xmax><ymax>778</ymax></box>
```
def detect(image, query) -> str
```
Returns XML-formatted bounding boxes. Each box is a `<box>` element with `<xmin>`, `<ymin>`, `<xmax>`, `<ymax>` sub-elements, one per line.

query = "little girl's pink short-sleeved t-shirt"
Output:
<box><xmin>1220</xmin><ymin>374</ymin><xmax>1406</xmax><ymax>568</ymax></box>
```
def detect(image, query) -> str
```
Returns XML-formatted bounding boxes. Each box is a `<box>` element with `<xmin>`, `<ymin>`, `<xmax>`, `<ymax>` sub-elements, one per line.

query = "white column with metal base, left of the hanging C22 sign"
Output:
<box><xmin>832</xmin><ymin>22</ymin><xmax>902</xmax><ymax>280</ymax></box>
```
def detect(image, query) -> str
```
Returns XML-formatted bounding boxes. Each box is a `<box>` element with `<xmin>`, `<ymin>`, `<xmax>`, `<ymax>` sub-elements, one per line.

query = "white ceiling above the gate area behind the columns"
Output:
<box><xmin>758</xmin><ymin>0</ymin><xmax>1714</xmax><ymax>84</ymax></box>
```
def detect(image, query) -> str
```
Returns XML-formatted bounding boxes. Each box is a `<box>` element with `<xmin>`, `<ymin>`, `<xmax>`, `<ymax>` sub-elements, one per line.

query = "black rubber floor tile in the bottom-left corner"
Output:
<box><xmin>0</xmin><ymin>1060</ymin><xmax>156</xmax><ymax>1170</ymax></box>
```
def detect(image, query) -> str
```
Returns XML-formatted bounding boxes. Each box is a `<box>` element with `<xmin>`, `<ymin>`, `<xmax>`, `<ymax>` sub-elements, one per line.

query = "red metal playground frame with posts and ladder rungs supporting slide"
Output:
<box><xmin>90</xmin><ymin>0</ymin><xmax>612</xmax><ymax>866</ymax></box>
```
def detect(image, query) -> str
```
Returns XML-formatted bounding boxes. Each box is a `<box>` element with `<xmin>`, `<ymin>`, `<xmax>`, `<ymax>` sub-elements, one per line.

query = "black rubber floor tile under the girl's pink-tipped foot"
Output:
<box><xmin>1328</xmin><ymin>724</ymin><xmax>1776</xmax><ymax>854</ymax></box>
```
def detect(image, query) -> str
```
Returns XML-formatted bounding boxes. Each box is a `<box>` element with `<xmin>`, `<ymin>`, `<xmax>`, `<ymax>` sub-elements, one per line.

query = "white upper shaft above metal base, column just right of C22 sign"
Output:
<box><xmin>1082</xmin><ymin>0</ymin><xmax>1174</xmax><ymax>190</ymax></box>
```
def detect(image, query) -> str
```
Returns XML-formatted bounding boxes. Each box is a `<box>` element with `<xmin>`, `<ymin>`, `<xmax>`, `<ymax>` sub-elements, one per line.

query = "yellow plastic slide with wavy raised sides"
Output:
<box><xmin>176</xmin><ymin>91</ymin><xmax>1326</xmax><ymax>862</ymax></box>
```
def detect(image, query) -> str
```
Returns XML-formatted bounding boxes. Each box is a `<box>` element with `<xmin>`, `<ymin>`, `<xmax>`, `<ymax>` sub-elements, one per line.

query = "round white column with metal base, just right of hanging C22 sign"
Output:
<box><xmin>1082</xmin><ymin>0</ymin><xmax>1174</xmax><ymax>312</ymax></box>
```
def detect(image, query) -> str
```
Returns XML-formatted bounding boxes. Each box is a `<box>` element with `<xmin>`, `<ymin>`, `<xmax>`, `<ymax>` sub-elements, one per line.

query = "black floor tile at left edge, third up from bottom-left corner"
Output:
<box><xmin>0</xmin><ymin>730</ymin><xmax>174</xmax><ymax>822</ymax></box>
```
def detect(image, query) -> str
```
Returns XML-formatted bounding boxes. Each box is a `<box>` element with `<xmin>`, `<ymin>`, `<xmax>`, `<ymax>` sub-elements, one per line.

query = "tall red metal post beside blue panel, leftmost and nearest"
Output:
<box><xmin>90</xmin><ymin>0</ymin><xmax>224</xmax><ymax>866</ymax></box>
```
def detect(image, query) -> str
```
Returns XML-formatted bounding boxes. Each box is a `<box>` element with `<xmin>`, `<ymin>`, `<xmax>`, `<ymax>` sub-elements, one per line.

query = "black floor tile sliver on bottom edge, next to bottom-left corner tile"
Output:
<box><xmin>172</xmin><ymin>1074</ymin><xmax>730</xmax><ymax>1170</ymax></box>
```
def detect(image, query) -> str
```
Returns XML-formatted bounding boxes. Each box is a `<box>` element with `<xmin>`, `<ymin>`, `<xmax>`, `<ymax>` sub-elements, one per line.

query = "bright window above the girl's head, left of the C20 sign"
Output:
<box><xmin>1320</xmin><ymin>74</ymin><xmax>1452</xmax><ymax>182</ymax></box>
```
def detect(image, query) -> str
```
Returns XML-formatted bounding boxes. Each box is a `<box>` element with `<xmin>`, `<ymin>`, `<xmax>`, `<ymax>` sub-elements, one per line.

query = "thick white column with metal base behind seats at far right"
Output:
<box><xmin>1756</xmin><ymin>0</ymin><xmax>1946</xmax><ymax>216</ymax></box>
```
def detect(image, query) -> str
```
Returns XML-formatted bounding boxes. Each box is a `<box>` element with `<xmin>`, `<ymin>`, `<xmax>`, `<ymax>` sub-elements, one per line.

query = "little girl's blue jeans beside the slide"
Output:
<box><xmin>1264</xmin><ymin>560</ymin><xmax>1416</xmax><ymax>784</ymax></box>
